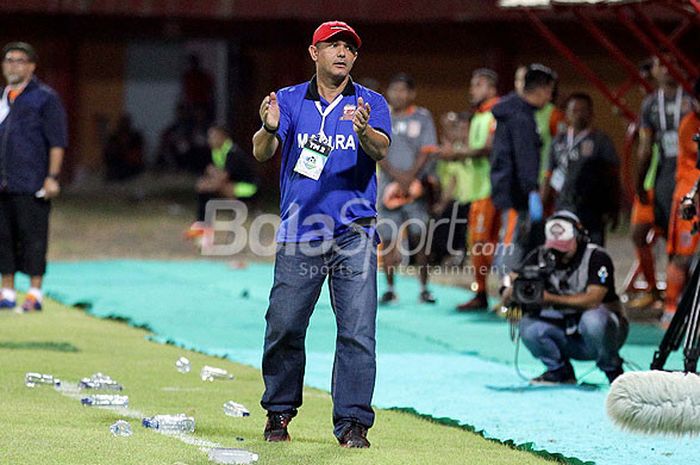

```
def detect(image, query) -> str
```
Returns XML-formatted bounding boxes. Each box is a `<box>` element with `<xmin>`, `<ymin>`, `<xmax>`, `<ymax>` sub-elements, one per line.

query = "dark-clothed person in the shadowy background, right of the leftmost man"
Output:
<box><xmin>104</xmin><ymin>114</ymin><xmax>145</xmax><ymax>181</ymax></box>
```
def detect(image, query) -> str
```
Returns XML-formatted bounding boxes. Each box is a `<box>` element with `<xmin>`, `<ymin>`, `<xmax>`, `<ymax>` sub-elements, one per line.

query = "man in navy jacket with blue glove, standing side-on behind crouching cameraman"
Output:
<box><xmin>491</xmin><ymin>64</ymin><xmax>556</xmax><ymax>273</ymax></box>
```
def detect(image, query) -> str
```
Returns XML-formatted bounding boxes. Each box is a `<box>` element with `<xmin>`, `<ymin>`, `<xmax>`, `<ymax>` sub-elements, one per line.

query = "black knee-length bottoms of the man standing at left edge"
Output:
<box><xmin>0</xmin><ymin>192</ymin><xmax>51</xmax><ymax>276</ymax></box>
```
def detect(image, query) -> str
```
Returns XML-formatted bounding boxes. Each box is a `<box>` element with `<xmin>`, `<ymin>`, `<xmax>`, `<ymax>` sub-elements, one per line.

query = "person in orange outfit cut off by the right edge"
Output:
<box><xmin>665</xmin><ymin>79</ymin><xmax>700</xmax><ymax>321</ymax></box>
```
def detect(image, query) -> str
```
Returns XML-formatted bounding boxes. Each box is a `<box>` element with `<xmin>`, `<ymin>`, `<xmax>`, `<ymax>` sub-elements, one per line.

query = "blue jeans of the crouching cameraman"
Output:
<box><xmin>520</xmin><ymin>307</ymin><xmax>629</xmax><ymax>371</ymax></box>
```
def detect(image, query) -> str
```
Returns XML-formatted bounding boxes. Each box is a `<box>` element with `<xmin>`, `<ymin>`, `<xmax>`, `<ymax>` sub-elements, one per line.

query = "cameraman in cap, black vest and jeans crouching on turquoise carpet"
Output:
<box><xmin>503</xmin><ymin>210</ymin><xmax>629</xmax><ymax>384</ymax></box>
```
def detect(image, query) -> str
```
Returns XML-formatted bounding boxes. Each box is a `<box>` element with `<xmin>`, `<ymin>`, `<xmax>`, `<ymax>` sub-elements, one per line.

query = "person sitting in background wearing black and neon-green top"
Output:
<box><xmin>187</xmin><ymin>125</ymin><xmax>258</xmax><ymax>237</ymax></box>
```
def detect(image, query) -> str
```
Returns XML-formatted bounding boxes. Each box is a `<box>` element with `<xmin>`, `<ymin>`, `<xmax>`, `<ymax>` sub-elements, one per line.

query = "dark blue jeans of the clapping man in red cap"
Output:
<box><xmin>261</xmin><ymin>229</ymin><xmax>377</xmax><ymax>435</ymax></box>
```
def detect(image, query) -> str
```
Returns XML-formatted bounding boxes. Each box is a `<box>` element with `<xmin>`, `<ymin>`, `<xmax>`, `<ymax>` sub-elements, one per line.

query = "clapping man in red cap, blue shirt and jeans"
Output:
<box><xmin>253</xmin><ymin>21</ymin><xmax>391</xmax><ymax>447</ymax></box>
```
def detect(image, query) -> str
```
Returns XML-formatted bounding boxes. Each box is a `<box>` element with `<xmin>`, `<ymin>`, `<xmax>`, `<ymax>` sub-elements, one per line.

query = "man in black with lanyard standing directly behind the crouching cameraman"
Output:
<box><xmin>542</xmin><ymin>93</ymin><xmax>620</xmax><ymax>247</ymax></box>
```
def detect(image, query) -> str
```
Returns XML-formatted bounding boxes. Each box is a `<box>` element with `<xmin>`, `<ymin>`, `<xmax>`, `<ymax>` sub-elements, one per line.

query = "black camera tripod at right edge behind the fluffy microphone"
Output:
<box><xmin>651</xmin><ymin>134</ymin><xmax>700</xmax><ymax>373</ymax></box>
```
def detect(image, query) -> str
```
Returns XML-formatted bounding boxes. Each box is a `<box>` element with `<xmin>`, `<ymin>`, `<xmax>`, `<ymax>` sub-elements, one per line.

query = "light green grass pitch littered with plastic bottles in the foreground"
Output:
<box><xmin>0</xmin><ymin>301</ymin><xmax>553</xmax><ymax>465</ymax></box>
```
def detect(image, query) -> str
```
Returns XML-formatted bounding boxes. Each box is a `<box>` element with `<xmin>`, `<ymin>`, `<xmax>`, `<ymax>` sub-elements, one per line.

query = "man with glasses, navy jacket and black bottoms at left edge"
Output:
<box><xmin>0</xmin><ymin>42</ymin><xmax>68</xmax><ymax>311</ymax></box>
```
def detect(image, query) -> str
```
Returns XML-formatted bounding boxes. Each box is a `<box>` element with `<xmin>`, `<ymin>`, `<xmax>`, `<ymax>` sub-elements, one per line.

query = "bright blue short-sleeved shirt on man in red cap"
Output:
<box><xmin>277</xmin><ymin>77</ymin><xmax>391</xmax><ymax>242</ymax></box>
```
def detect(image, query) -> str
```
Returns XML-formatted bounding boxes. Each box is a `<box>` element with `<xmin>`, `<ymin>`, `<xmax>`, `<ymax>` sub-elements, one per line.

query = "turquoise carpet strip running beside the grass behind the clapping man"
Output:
<box><xmin>19</xmin><ymin>261</ymin><xmax>700</xmax><ymax>465</ymax></box>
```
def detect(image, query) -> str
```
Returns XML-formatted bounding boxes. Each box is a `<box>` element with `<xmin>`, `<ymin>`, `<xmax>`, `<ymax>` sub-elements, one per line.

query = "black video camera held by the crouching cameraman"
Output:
<box><xmin>511</xmin><ymin>250</ymin><xmax>556</xmax><ymax>313</ymax></box>
